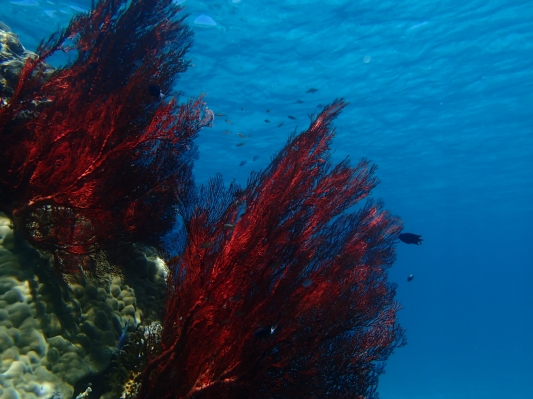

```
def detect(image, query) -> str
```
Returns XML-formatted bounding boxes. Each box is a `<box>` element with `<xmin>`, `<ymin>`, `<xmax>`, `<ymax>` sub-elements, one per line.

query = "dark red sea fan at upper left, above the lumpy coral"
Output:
<box><xmin>0</xmin><ymin>0</ymin><xmax>210</xmax><ymax>272</ymax></box>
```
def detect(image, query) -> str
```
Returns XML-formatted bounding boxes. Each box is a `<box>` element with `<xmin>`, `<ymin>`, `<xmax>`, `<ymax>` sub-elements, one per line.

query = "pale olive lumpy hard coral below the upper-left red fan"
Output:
<box><xmin>0</xmin><ymin>214</ymin><xmax>166</xmax><ymax>399</ymax></box>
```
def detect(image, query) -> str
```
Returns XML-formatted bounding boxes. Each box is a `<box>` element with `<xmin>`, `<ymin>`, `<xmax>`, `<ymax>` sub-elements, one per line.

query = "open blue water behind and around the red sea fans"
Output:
<box><xmin>0</xmin><ymin>0</ymin><xmax>533</xmax><ymax>399</ymax></box>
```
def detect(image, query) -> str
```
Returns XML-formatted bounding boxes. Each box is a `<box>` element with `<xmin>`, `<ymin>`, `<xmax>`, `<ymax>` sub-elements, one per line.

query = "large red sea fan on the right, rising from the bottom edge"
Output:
<box><xmin>139</xmin><ymin>100</ymin><xmax>404</xmax><ymax>399</ymax></box>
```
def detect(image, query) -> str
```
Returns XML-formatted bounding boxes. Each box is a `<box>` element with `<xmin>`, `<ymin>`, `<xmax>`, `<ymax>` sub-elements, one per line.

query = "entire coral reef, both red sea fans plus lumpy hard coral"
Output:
<box><xmin>0</xmin><ymin>0</ymin><xmax>405</xmax><ymax>399</ymax></box>
